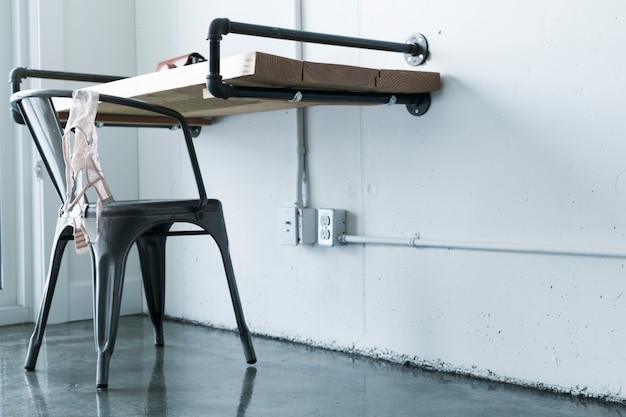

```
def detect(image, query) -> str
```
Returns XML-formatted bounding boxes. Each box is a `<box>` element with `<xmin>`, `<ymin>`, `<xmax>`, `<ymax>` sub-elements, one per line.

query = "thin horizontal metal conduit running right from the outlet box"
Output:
<box><xmin>338</xmin><ymin>234</ymin><xmax>626</xmax><ymax>258</ymax></box>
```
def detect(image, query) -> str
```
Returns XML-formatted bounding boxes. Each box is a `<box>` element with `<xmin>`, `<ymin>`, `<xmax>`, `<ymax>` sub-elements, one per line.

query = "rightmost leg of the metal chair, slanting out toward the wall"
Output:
<box><xmin>211</xmin><ymin>218</ymin><xmax>256</xmax><ymax>364</ymax></box>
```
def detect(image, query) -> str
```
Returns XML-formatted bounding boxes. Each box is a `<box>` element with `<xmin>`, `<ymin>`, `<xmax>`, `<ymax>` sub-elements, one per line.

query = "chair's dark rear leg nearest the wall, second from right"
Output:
<box><xmin>137</xmin><ymin>232</ymin><xmax>169</xmax><ymax>346</ymax></box>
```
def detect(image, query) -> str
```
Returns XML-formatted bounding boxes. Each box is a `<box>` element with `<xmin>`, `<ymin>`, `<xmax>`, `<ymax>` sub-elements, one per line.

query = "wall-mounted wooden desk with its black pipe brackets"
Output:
<box><xmin>10</xmin><ymin>19</ymin><xmax>441</xmax><ymax>126</ymax></box>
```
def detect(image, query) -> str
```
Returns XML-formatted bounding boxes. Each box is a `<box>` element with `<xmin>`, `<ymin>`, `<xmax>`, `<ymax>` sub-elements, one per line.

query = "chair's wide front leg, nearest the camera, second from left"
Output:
<box><xmin>94</xmin><ymin>239</ymin><xmax>127</xmax><ymax>388</ymax></box>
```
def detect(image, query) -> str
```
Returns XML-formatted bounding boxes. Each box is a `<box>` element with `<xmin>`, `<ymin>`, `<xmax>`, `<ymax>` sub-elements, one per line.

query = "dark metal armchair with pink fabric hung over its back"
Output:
<box><xmin>11</xmin><ymin>90</ymin><xmax>256</xmax><ymax>388</ymax></box>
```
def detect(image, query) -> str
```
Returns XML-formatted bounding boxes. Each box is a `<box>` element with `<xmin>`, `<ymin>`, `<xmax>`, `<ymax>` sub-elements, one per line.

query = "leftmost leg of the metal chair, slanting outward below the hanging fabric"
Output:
<box><xmin>24</xmin><ymin>228</ymin><xmax>67</xmax><ymax>371</ymax></box>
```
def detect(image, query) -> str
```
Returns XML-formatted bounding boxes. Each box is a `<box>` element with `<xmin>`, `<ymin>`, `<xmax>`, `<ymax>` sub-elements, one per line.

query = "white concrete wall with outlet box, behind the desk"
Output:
<box><xmin>136</xmin><ymin>0</ymin><xmax>626</xmax><ymax>398</ymax></box>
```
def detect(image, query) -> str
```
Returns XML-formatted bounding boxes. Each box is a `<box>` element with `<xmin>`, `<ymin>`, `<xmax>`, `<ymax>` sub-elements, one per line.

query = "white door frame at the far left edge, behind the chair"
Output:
<box><xmin>0</xmin><ymin>0</ymin><xmax>36</xmax><ymax>325</ymax></box>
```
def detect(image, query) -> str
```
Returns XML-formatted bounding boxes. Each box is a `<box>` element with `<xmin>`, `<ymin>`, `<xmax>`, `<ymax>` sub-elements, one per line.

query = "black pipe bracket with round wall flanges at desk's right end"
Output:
<box><xmin>207</xmin><ymin>18</ymin><xmax>430</xmax><ymax>116</ymax></box>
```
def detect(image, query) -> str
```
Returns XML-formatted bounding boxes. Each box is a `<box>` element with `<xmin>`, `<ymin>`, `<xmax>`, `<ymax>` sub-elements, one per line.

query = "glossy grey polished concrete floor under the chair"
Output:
<box><xmin>0</xmin><ymin>316</ymin><xmax>626</xmax><ymax>417</ymax></box>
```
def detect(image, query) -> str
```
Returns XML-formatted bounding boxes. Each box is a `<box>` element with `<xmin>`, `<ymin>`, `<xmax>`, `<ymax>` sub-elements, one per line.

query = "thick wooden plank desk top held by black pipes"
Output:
<box><xmin>55</xmin><ymin>52</ymin><xmax>441</xmax><ymax>125</ymax></box>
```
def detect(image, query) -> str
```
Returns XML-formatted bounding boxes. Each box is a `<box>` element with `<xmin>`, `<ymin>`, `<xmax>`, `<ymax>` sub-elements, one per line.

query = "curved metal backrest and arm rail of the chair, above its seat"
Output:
<box><xmin>11</xmin><ymin>90</ymin><xmax>208</xmax><ymax>206</ymax></box>
